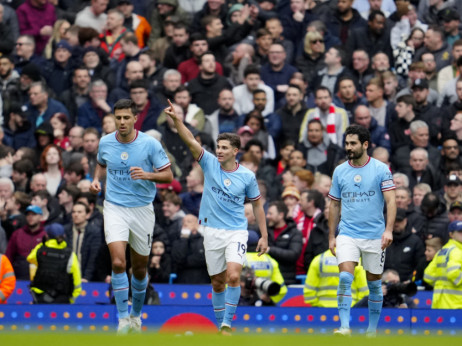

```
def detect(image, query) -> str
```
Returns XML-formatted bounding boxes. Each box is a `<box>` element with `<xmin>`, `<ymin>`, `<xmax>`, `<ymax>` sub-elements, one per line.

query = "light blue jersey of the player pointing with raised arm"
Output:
<box><xmin>197</xmin><ymin>149</ymin><xmax>260</xmax><ymax>230</ymax></box>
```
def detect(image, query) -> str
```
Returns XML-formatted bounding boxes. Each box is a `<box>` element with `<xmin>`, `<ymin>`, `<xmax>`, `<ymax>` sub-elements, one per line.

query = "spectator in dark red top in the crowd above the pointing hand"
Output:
<box><xmin>178</xmin><ymin>33</ymin><xmax>223</xmax><ymax>83</ymax></box>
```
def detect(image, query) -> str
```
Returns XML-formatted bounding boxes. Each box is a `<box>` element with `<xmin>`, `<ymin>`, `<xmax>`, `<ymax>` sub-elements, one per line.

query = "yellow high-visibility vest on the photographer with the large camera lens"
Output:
<box><xmin>246</xmin><ymin>252</ymin><xmax>287</xmax><ymax>304</ymax></box>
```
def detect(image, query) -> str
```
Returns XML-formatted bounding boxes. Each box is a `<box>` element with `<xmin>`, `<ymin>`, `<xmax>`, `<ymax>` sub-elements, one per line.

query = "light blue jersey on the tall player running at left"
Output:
<box><xmin>97</xmin><ymin>130</ymin><xmax>170</xmax><ymax>208</ymax></box>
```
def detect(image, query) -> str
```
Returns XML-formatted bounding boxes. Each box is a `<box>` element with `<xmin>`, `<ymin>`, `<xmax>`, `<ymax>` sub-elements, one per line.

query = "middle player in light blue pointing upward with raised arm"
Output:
<box><xmin>165</xmin><ymin>101</ymin><xmax>268</xmax><ymax>335</ymax></box>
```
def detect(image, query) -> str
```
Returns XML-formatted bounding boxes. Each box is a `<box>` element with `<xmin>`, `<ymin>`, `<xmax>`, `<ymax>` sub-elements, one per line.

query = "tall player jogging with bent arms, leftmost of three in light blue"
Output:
<box><xmin>90</xmin><ymin>99</ymin><xmax>173</xmax><ymax>334</ymax></box>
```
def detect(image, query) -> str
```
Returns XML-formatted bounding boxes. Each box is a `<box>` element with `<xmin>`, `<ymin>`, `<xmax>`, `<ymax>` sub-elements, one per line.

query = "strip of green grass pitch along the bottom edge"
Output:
<box><xmin>0</xmin><ymin>333</ymin><xmax>462</xmax><ymax>346</ymax></box>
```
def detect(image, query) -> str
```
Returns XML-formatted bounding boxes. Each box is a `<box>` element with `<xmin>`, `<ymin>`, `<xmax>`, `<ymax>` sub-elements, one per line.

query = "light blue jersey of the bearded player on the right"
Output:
<box><xmin>329</xmin><ymin>157</ymin><xmax>395</xmax><ymax>239</ymax></box>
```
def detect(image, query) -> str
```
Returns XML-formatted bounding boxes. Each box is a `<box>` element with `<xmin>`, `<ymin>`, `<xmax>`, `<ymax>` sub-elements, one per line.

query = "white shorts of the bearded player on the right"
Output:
<box><xmin>335</xmin><ymin>235</ymin><xmax>385</xmax><ymax>274</ymax></box>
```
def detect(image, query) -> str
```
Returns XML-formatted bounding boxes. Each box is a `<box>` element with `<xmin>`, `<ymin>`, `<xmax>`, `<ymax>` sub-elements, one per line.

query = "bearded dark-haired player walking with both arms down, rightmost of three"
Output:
<box><xmin>329</xmin><ymin>125</ymin><xmax>396</xmax><ymax>337</ymax></box>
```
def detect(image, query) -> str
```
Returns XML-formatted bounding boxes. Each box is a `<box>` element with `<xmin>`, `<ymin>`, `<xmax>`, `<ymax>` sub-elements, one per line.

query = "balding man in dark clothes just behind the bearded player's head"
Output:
<box><xmin>354</xmin><ymin>105</ymin><xmax>391</xmax><ymax>154</ymax></box>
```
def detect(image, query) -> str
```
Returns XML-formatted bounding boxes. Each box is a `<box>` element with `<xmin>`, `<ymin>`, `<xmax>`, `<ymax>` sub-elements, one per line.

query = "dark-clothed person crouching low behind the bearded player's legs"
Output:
<box><xmin>355</xmin><ymin>269</ymin><xmax>417</xmax><ymax>309</ymax></box>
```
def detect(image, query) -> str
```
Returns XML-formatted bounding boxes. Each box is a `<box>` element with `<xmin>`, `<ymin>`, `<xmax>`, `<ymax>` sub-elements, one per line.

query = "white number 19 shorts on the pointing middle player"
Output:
<box><xmin>199</xmin><ymin>226</ymin><xmax>249</xmax><ymax>276</ymax></box>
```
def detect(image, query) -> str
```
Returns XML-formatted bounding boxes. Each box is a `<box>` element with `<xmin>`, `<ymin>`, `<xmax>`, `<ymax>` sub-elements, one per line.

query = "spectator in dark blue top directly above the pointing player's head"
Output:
<box><xmin>204</xmin><ymin>89</ymin><xmax>240</xmax><ymax>140</ymax></box>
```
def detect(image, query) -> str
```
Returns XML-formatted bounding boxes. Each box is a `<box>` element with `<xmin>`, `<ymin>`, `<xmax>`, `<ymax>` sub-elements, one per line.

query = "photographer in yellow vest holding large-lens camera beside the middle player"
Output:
<box><xmin>239</xmin><ymin>252</ymin><xmax>287</xmax><ymax>306</ymax></box>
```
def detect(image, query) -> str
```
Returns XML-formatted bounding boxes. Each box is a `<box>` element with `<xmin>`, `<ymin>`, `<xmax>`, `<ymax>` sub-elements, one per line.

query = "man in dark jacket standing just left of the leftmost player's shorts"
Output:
<box><xmin>64</xmin><ymin>202</ymin><xmax>103</xmax><ymax>282</ymax></box>
